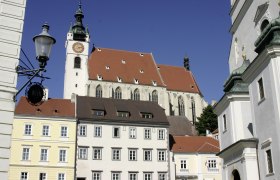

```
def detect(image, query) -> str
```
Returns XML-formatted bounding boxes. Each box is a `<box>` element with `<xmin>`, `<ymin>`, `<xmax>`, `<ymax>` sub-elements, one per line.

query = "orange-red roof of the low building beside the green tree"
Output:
<box><xmin>171</xmin><ymin>136</ymin><xmax>220</xmax><ymax>153</ymax></box>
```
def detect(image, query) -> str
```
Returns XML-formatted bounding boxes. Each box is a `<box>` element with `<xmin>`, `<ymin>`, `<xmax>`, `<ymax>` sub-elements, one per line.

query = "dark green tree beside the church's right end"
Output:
<box><xmin>195</xmin><ymin>105</ymin><xmax>218</xmax><ymax>135</ymax></box>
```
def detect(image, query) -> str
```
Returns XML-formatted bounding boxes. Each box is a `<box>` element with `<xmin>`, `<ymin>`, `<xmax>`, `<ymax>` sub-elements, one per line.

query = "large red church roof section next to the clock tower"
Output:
<box><xmin>88</xmin><ymin>48</ymin><xmax>164</xmax><ymax>86</ymax></box>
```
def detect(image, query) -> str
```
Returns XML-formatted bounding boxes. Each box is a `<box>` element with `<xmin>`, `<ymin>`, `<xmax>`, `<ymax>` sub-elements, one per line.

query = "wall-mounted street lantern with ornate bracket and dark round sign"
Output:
<box><xmin>15</xmin><ymin>23</ymin><xmax>56</xmax><ymax>105</ymax></box>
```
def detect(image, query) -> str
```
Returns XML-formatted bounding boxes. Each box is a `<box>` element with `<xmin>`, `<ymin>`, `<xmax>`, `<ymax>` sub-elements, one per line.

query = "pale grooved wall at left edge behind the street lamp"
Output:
<box><xmin>0</xmin><ymin>0</ymin><xmax>26</xmax><ymax>179</ymax></box>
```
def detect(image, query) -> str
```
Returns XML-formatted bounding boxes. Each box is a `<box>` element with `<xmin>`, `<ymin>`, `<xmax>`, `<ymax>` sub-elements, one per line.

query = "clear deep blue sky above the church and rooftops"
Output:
<box><xmin>18</xmin><ymin>0</ymin><xmax>231</xmax><ymax>103</ymax></box>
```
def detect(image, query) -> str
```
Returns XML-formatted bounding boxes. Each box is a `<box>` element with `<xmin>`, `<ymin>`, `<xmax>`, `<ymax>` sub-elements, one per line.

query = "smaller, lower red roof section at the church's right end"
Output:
<box><xmin>158</xmin><ymin>65</ymin><xmax>201</xmax><ymax>94</ymax></box>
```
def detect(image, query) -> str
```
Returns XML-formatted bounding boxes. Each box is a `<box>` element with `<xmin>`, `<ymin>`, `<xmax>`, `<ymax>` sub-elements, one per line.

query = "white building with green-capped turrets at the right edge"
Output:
<box><xmin>215</xmin><ymin>0</ymin><xmax>280</xmax><ymax>180</ymax></box>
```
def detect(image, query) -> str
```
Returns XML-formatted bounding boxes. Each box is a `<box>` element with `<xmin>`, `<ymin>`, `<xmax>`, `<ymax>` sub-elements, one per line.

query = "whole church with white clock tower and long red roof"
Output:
<box><xmin>64</xmin><ymin>5</ymin><xmax>207</xmax><ymax>122</ymax></box>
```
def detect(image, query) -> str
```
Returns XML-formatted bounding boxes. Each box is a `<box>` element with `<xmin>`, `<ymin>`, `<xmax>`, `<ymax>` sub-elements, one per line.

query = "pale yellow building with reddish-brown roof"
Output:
<box><xmin>9</xmin><ymin>98</ymin><xmax>76</xmax><ymax>180</ymax></box>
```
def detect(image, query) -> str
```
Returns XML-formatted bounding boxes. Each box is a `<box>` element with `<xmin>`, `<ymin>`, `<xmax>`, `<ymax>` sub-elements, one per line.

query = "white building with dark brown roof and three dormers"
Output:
<box><xmin>76</xmin><ymin>96</ymin><xmax>170</xmax><ymax>180</ymax></box>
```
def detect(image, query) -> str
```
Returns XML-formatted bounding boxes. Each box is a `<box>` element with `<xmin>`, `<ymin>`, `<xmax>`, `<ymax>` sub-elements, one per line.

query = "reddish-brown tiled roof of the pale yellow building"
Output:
<box><xmin>15</xmin><ymin>97</ymin><xmax>75</xmax><ymax>118</ymax></box>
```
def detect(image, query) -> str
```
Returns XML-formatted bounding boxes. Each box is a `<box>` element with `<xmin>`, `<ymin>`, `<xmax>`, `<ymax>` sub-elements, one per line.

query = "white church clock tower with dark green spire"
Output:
<box><xmin>63</xmin><ymin>3</ymin><xmax>90</xmax><ymax>99</ymax></box>
